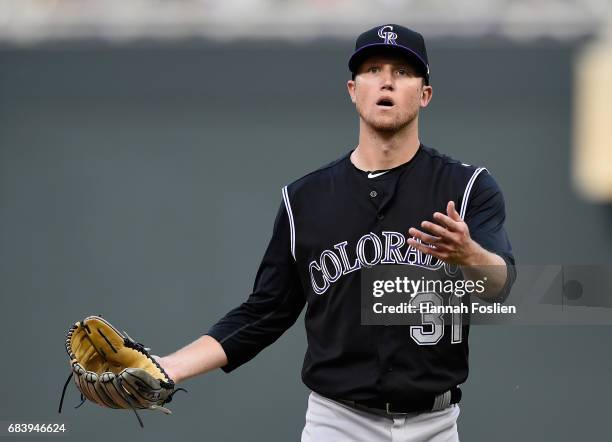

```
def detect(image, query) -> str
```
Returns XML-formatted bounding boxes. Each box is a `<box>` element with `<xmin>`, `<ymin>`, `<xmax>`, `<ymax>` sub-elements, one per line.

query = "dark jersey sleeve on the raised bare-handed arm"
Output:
<box><xmin>464</xmin><ymin>171</ymin><xmax>516</xmax><ymax>301</ymax></box>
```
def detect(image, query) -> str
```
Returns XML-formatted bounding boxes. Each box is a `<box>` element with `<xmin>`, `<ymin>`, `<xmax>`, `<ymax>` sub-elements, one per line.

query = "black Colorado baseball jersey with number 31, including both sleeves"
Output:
<box><xmin>208</xmin><ymin>144</ymin><xmax>516</xmax><ymax>402</ymax></box>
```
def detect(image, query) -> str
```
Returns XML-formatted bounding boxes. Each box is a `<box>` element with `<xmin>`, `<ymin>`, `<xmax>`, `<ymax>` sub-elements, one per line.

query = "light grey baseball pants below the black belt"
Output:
<box><xmin>301</xmin><ymin>391</ymin><xmax>460</xmax><ymax>442</ymax></box>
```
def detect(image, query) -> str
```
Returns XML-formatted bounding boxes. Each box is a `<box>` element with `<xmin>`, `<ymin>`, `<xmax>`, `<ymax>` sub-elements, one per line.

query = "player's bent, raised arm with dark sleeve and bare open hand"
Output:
<box><xmin>408</xmin><ymin>173</ymin><xmax>516</xmax><ymax>301</ymax></box>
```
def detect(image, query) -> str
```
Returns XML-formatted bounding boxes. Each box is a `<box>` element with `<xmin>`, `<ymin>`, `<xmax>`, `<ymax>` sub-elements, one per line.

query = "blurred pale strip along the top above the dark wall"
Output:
<box><xmin>0</xmin><ymin>0</ymin><xmax>610</xmax><ymax>42</ymax></box>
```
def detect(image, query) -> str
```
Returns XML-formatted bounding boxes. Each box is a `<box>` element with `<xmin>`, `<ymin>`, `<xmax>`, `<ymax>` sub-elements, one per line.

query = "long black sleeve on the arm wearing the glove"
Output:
<box><xmin>207</xmin><ymin>200</ymin><xmax>305</xmax><ymax>373</ymax></box>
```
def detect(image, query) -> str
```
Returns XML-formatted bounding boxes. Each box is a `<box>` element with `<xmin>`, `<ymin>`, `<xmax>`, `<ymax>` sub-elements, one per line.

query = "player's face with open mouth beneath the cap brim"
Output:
<box><xmin>347</xmin><ymin>55</ymin><xmax>432</xmax><ymax>132</ymax></box>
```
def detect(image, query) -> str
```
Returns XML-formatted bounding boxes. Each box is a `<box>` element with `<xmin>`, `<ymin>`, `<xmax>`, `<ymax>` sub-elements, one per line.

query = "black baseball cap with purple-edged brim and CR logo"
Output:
<box><xmin>349</xmin><ymin>24</ymin><xmax>429</xmax><ymax>84</ymax></box>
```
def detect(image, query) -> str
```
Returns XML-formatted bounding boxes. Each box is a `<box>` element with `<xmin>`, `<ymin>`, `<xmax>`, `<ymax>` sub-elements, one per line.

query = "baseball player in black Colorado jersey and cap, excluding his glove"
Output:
<box><xmin>159</xmin><ymin>24</ymin><xmax>516</xmax><ymax>442</ymax></box>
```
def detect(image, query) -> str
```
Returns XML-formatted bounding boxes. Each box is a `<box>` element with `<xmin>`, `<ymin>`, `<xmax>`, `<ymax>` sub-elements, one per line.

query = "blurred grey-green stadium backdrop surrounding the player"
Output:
<box><xmin>0</xmin><ymin>0</ymin><xmax>612</xmax><ymax>441</ymax></box>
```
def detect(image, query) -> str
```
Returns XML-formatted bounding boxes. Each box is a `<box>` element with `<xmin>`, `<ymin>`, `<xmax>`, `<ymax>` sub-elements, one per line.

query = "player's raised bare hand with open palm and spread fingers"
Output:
<box><xmin>408</xmin><ymin>201</ymin><xmax>482</xmax><ymax>265</ymax></box>
